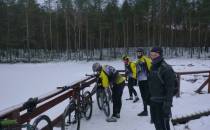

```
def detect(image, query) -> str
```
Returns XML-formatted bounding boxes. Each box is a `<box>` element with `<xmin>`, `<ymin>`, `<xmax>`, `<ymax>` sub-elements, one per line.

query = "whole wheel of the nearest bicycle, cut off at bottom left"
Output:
<box><xmin>32</xmin><ymin>115</ymin><xmax>53</xmax><ymax>130</ymax></box>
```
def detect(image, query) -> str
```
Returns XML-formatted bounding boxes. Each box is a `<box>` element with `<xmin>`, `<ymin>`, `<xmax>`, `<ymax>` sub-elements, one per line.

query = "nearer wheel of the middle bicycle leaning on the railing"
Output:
<box><xmin>61</xmin><ymin>103</ymin><xmax>80</xmax><ymax>130</ymax></box>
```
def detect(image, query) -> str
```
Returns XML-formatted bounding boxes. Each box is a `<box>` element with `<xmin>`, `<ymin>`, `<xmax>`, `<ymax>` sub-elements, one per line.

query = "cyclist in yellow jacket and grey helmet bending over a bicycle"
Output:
<box><xmin>92</xmin><ymin>63</ymin><xmax>125</xmax><ymax>122</ymax></box>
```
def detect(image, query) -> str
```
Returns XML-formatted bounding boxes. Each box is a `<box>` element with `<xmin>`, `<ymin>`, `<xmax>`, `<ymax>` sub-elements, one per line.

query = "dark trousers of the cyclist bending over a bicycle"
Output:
<box><xmin>112</xmin><ymin>82</ymin><xmax>125</xmax><ymax>115</ymax></box>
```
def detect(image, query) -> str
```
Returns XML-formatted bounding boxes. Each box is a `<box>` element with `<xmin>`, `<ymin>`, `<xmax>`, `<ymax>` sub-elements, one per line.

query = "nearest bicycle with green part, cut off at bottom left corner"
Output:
<box><xmin>0</xmin><ymin>98</ymin><xmax>53</xmax><ymax>130</ymax></box>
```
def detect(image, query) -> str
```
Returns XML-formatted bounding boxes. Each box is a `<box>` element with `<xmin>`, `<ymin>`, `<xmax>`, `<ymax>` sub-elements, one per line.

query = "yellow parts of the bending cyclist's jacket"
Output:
<box><xmin>99</xmin><ymin>65</ymin><xmax>125</xmax><ymax>88</ymax></box>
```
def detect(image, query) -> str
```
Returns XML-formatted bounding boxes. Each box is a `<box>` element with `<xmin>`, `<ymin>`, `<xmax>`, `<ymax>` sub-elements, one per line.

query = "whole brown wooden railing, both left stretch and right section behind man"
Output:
<box><xmin>0</xmin><ymin>70</ymin><xmax>210</xmax><ymax>126</ymax></box>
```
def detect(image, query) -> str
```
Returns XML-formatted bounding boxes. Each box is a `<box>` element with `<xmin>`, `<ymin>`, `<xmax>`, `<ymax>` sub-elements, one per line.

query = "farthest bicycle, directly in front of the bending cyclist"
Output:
<box><xmin>86</xmin><ymin>74</ymin><xmax>112</xmax><ymax>117</ymax></box>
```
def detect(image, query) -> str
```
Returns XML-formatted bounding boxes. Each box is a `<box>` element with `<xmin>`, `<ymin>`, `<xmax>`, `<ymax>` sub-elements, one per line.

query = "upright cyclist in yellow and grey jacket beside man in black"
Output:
<box><xmin>136</xmin><ymin>48</ymin><xmax>152</xmax><ymax>116</ymax></box>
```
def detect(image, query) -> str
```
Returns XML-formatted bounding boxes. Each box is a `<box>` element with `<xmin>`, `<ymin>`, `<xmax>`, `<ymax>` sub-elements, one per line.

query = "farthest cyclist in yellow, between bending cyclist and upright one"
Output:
<box><xmin>123</xmin><ymin>55</ymin><xmax>139</xmax><ymax>103</ymax></box>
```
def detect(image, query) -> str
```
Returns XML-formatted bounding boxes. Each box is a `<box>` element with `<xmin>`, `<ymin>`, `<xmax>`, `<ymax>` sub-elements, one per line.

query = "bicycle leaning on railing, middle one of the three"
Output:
<box><xmin>61</xmin><ymin>84</ymin><xmax>93</xmax><ymax>130</ymax></box>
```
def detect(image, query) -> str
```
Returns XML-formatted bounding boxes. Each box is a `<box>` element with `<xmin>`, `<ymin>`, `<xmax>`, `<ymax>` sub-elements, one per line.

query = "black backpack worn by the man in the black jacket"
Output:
<box><xmin>157</xmin><ymin>63</ymin><xmax>179</xmax><ymax>96</ymax></box>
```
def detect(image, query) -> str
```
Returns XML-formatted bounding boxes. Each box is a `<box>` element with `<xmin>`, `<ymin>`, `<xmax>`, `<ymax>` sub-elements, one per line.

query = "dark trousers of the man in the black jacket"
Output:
<box><xmin>150</xmin><ymin>101</ymin><xmax>170</xmax><ymax>130</ymax></box>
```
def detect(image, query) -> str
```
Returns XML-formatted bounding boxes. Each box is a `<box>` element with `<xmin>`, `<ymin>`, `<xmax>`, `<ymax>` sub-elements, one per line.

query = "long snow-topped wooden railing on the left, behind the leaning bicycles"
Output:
<box><xmin>0</xmin><ymin>77</ymin><xmax>95</xmax><ymax>126</ymax></box>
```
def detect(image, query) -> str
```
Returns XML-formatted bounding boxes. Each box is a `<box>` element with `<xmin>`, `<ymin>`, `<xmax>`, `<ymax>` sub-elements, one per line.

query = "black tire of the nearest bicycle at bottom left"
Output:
<box><xmin>32</xmin><ymin>115</ymin><xmax>53</xmax><ymax>130</ymax></box>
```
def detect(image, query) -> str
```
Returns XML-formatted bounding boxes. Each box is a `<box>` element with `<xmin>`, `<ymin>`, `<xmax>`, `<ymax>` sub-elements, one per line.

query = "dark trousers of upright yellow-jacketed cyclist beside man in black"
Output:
<box><xmin>138</xmin><ymin>80</ymin><xmax>149</xmax><ymax>111</ymax></box>
